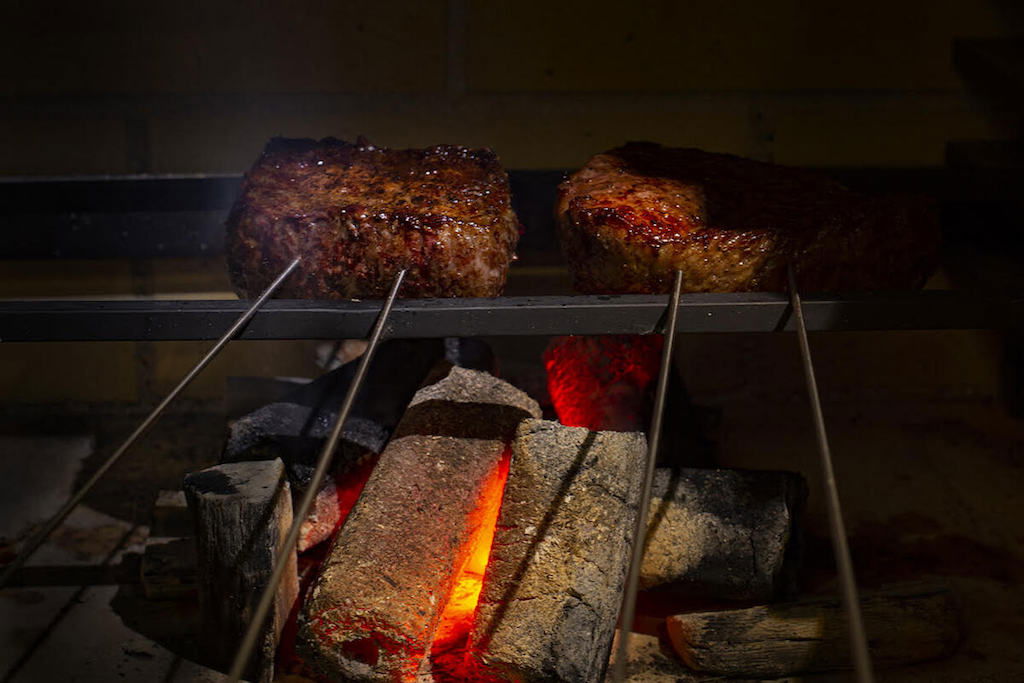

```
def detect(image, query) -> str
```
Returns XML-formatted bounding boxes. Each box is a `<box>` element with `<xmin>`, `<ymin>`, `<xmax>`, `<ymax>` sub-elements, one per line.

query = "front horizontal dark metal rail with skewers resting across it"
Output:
<box><xmin>0</xmin><ymin>291</ymin><xmax>1024</xmax><ymax>342</ymax></box>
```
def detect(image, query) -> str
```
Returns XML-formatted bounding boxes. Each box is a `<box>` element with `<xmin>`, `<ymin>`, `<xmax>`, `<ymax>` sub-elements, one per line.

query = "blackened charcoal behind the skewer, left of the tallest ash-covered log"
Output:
<box><xmin>221</xmin><ymin>339</ymin><xmax>444</xmax><ymax>488</ymax></box>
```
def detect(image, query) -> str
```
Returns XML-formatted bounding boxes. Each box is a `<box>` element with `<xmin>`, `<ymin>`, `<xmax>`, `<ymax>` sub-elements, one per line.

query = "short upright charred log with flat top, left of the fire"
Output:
<box><xmin>184</xmin><ymin>460</ymin><xmax>298</xmax><ymax>681</ymax></box>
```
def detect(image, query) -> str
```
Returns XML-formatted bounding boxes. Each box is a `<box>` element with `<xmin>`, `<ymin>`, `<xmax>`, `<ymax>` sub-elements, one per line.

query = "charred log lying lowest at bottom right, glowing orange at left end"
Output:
<box><xmin>668</xmin><ymin>584</ymin><xmax>961</xmax><ymax>678</ymax></box>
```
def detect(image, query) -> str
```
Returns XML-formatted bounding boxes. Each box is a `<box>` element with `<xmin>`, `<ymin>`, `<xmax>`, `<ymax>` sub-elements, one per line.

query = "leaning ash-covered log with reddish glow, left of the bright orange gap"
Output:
<box><xmin>300</xmin><ymin>368</ymin><xmax>540</xmax><ymax>681</ymax></box>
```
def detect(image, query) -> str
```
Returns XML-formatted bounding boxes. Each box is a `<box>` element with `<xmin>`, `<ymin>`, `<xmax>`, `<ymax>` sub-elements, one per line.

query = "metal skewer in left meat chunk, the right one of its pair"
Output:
<box><xmin>228</xmin><ymin>270</ymin><xmax>406</xmax><ymax>683</ymax></box>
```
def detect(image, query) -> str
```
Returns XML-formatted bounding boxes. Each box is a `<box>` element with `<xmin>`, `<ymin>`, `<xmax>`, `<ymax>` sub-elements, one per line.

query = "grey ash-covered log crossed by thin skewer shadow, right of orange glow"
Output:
<box><xmin>469</xmin><ymin>420</ymin><xmax>646</xmax><ymax>682</ymax></box>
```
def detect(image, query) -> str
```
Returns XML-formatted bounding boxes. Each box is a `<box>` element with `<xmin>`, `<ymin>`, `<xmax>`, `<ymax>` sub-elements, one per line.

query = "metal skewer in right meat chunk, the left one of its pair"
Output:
<box><xmin>611</xmin><ymin>270</ymin><xmax>683</xmax><ymax>683</ymax></box>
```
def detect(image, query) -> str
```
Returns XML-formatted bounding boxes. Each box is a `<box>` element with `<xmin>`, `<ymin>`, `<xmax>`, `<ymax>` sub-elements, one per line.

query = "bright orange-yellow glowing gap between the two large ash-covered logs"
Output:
<box><xmin>432</xmin><ymin>452</ymin><xmax>511</xmax><ymax>654</ymax></box>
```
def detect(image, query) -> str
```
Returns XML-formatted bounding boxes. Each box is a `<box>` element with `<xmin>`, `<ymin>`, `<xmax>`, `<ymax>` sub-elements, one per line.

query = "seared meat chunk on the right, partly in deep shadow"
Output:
<box><xmin>557</xmin><ymin>142</ymin><xmax>938</xmax><ymax>293</ymax></box>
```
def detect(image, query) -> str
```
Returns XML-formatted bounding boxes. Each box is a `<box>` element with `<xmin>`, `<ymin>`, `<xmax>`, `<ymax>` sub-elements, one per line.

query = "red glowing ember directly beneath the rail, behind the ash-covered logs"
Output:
<box><xmin>544</xmin><ymin>335</ymin><xmax>664</xmax><ymax>431</ymax></box>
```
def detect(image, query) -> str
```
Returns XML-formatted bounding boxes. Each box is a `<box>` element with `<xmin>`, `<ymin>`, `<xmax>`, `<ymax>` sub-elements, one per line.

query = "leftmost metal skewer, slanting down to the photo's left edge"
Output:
<box><xmin>0</xmin><ymin>258</ymin><xmax>301</xmax><ymax>587</ymax></box>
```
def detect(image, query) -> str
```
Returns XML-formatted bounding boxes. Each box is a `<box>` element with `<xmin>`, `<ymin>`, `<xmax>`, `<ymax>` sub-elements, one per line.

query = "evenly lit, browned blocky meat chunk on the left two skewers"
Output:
<box><xmin>227</xmin><ymin>138</ymin><xmax>518</xmax><ymax>299</ymax></box>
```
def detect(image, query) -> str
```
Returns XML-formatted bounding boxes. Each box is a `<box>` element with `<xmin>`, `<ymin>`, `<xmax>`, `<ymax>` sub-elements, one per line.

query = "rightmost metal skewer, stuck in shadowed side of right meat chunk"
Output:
<box><xmin>788</xmin><ymin>264</ymin><xmax>874</xmax><ymax>683</ymax></box>
